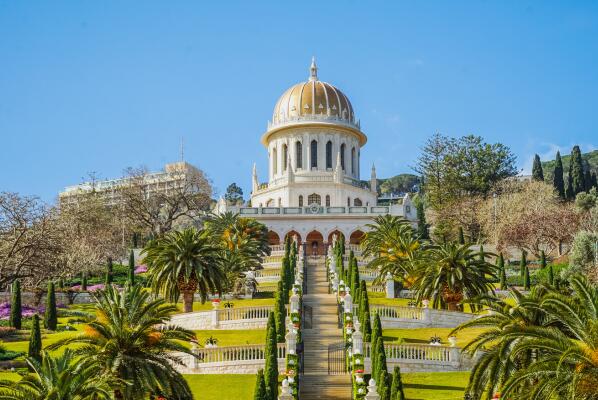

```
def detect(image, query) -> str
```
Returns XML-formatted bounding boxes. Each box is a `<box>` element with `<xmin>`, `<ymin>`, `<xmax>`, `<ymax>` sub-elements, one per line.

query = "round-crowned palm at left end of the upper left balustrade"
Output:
<box><xmin>142</xmin><ymin>227</ymin><xmax>225</xmax><ymax>312</ymax></box>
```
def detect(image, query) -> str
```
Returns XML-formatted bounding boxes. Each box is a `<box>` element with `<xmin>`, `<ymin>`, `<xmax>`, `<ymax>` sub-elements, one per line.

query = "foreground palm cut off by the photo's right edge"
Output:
<box><xmin>503</xmin><ymin>275</ymin><xmax>598</xmax><ymax>400</ymax></box>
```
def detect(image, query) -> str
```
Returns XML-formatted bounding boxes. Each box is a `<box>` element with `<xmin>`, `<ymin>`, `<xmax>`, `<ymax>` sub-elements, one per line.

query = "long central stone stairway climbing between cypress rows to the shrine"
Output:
<box><xmin>300</xmin><ymin>256</ymin><xmax>351</xmax><ymax>400</ymax></box>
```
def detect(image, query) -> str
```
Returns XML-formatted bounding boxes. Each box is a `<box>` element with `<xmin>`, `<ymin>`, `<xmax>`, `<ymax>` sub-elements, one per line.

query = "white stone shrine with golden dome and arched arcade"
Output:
<box><xmin>217</xmin><ymin>60</ymin><xmax>416</xmax><ymax>254</ymax></box>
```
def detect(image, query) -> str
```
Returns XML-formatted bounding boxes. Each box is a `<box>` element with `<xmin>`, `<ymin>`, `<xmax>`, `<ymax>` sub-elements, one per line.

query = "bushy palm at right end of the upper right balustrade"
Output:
<box><xmin>413</xmin><ymin>243</ymin><xmax>497</xmax><ymax>310</ymax></box>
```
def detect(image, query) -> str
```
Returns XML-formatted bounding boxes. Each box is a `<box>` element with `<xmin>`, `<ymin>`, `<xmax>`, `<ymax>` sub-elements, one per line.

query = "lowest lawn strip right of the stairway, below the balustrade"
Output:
<box><xmin>401</xmin><ymin>372</ymin><xmax>469</xmax><ymax>400</ymax></box>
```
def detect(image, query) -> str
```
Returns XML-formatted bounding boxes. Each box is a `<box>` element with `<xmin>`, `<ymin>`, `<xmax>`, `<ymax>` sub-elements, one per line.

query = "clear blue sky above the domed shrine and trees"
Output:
<box><xmin>0</xmin><ymin>0</ymin><xmax>598</xmax><ymax>202</ymax></box>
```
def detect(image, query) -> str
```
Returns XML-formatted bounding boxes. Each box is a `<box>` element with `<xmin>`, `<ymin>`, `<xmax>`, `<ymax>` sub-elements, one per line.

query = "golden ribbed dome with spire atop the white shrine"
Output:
<box><xmin>263</xmin><ymin>59</ymin><xmax>367</xmax><ymax>147</ymax></box>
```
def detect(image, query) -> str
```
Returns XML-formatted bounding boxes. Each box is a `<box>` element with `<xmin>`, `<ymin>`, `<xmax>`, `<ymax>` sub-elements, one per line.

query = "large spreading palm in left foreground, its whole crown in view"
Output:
<box><xmin>48</xmin><ymin>285</ymin><xmax>195</xmax><ymax>400</ymax></box>
